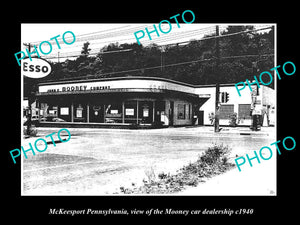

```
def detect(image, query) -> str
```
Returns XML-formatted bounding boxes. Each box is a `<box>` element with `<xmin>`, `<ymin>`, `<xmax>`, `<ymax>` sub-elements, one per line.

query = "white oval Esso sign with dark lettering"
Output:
<box><xmin>21</xmin><ymin>58</ymin><xmax>51</xmax><ymax>78</ymax></box>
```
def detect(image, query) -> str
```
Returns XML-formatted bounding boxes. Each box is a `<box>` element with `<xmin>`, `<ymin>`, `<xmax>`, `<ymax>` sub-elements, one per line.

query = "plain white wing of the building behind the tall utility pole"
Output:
<box><xmin>195</xmin><ymin>84</ymin><xmax>276</xmax><ymax>126</ymax></box>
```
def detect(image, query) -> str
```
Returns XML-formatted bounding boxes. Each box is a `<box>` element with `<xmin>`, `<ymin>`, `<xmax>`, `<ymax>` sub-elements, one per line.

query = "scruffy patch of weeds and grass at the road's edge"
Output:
<box><xmin>120</xmin><ymin>144</ymin><xmax>234</xmax><ymax>194</ymax></box>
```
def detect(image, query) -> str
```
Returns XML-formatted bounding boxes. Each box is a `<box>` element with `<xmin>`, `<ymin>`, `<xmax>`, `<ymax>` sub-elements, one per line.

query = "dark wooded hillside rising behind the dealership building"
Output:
<box><xmin>39</xmin><ymin>26</ymin><xmax>274</xmax><ymax>87</ymax></box>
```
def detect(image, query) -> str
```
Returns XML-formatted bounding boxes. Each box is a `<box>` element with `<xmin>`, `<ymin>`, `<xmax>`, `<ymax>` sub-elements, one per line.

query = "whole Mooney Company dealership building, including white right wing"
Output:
<box><xmin>32</xmin><ymin>77</ymin><xmax>275</xmax><ymax>127</ymax></box>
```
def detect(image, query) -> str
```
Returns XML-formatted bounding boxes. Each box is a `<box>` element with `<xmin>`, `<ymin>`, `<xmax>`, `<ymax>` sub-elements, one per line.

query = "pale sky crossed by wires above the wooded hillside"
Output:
<box><xmin>21</xmin><ymin>22</ymin><xmax>274</xmax><ymax>62</ymax></box>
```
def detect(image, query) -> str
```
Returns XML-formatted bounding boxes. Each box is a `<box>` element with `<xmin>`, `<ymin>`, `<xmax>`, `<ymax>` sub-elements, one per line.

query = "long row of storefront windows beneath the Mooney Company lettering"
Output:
<box><xmin>40</xmin><ymin>97</ymin><xmax>168</xmax><ymax>125</ymax></box>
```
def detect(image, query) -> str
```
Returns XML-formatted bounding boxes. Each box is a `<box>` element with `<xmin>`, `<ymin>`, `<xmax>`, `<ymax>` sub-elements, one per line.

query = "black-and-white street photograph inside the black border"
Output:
<box><xmin>20</xmin><ymin>22</ymin><xmax>276</xmax><ymax>196</ymax></box>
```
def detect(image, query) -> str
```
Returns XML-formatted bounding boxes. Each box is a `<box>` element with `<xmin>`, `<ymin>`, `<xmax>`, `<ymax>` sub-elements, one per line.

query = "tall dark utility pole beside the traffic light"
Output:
<box><xmin>215</xmin><ymin>25</ymin><xmax>220</xmax><ymax>132</ymax></box>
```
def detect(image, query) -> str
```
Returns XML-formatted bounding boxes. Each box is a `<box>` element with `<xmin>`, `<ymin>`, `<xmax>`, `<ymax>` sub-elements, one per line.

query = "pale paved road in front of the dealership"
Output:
<box><xmin>22</xmin><ymin>128</ymin><xmax>275</xmax><ymax>195</ymax></box>
